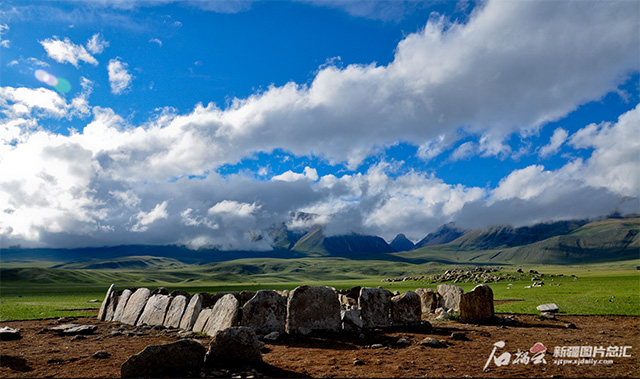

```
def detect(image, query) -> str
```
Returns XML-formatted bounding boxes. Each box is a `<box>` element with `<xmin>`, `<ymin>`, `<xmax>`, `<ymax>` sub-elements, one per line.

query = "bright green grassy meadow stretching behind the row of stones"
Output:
<box><xmin>0</xmin><ymin>258</ymin><xmax>640</xmax><ymax>321</ymax></box>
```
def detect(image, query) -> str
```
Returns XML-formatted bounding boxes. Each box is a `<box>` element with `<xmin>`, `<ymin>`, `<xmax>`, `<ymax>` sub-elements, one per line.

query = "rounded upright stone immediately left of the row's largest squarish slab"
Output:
<box><xmin>240</xmin><ymin>290</ymin><xmax>287</xmax><ymax>334</ymax></box>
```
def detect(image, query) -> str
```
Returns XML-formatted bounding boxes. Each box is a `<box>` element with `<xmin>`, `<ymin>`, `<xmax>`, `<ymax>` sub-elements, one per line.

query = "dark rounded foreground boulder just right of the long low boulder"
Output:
<box><xmin>205</xmin><ymin>326</ymin><xmax>263</xmax><ymax>367</ymax></box>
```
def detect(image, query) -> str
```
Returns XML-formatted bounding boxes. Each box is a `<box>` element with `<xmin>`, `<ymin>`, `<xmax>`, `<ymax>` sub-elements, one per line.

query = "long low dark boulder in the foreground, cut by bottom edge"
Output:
<box><xmin>120</xmin><ymin>339</ymin><xmax>202</xmax><ymax>378</ymax></box>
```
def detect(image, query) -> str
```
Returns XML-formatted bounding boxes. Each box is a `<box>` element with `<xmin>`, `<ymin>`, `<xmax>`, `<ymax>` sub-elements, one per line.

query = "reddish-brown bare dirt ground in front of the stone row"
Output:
<box><xmin>0</xmin><ymin>315</ymin><xmax>640</xmax><ymax>378</ymax></box>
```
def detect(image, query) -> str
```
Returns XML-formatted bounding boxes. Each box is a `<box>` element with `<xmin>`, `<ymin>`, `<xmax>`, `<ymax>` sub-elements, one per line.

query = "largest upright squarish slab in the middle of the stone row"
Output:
<box><xmin>286</xmin><ymin>286</ymin><xmax>342</xmax><ymax>333</ymax></box>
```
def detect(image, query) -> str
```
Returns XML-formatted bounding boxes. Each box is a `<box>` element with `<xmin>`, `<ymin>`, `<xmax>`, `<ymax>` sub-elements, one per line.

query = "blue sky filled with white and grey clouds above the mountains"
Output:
<box><xmin>0</xmin><ymin>0</ymin><xmax>640</xmax><ymax>250</ymax></box>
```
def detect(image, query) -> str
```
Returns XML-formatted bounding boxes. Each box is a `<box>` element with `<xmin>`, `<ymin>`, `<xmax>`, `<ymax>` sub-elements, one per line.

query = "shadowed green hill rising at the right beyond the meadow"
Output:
<box><xmin>394</xmin><ymin>218</ymin><xmax>640</xmax><ymax>264</ymax></box>
